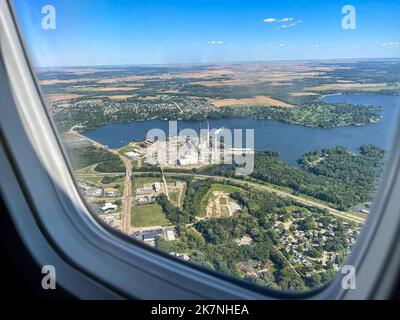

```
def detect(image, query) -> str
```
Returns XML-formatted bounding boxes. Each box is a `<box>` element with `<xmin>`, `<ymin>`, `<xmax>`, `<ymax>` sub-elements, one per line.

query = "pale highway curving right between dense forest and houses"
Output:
<box><xmin>135</xmin><ymin>172</ymin><xmax>365</xmax><ymax>224</ymax></box>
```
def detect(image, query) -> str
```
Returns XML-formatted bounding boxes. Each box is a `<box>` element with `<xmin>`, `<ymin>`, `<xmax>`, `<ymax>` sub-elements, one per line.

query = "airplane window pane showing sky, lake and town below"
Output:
<box><xmin>13</xmin><ymin>0</ymin><xmax>400</xmax><ymax>291</ymax></box>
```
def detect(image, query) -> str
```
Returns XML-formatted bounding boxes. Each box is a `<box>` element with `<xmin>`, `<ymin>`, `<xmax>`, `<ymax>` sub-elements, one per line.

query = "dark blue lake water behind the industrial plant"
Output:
<box><xmin>83</xmin><ymin>95</ymin><xmax>400</xmax><ymax>165</ymax></box>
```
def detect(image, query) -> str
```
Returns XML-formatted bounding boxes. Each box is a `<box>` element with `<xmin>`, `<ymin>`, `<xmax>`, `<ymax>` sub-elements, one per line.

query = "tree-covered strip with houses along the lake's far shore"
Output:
<box><xmin>52</xmin><ymin>97</ymin><xmax>380</xmax><ymax>131</ymax></box>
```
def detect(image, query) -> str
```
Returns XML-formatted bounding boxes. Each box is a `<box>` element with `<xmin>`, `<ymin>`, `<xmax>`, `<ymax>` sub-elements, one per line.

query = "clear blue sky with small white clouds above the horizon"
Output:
<box><xmin>14</xmin><ymin>0</ymin><xmax>400</xmax><ymax>67</ymax></box>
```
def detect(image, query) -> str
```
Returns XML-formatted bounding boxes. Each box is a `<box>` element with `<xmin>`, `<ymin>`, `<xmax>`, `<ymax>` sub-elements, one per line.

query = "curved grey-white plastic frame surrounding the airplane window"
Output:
<box><xmin>0</xmin><ymin>1</ymin><xmax>400</xmax><ymax>300</ymax></box>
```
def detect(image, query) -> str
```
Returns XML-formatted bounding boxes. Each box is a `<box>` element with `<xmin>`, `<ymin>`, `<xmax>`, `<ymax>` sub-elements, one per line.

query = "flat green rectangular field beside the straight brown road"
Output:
<box><xmin>131</xmin><ymin>204</ymin><xmax>171</xmax><ymax>228</ymax></box>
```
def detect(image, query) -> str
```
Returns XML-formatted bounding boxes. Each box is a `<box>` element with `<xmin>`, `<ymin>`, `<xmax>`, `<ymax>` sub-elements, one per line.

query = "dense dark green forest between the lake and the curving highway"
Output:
<box><xmin>213</xmin><ymin>145</ymin><xmax>384</xmax><ymax>210</ymax></box>
